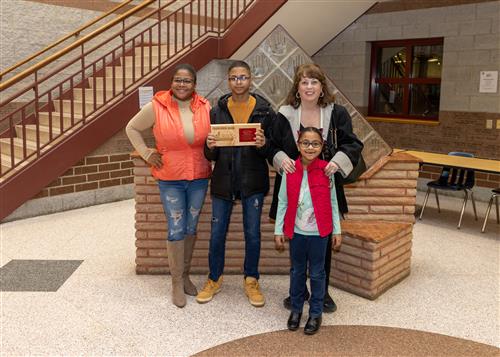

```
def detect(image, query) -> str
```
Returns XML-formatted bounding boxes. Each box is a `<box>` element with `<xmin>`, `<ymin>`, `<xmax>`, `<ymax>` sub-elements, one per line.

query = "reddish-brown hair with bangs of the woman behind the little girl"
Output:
<box><xmin>285</xmin><ymin>63</ymin><xmax>335</xmax><ymax>109</ymax></box>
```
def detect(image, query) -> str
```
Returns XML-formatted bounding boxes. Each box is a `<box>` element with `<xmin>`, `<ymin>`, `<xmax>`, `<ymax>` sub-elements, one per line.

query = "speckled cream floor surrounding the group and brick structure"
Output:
<box><xmin>0</xmin><ymin>193</ymin><xmax>500</xmax><ymax>356</ymax></box>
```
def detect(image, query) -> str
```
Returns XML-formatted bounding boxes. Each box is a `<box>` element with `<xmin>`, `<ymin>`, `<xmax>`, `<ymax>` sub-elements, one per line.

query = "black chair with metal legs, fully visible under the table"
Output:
<box><xmin>419</xmin><ymin>151</ymin><xmax>477</xmax><ymax>229</ymax></box>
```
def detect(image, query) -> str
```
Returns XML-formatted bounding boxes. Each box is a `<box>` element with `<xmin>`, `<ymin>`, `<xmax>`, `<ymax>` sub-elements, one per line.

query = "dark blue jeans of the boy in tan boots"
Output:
<box><xmin>208</xmin><ymin>193</ymin><xmax>264</xmax><ymax>281</ymax></box>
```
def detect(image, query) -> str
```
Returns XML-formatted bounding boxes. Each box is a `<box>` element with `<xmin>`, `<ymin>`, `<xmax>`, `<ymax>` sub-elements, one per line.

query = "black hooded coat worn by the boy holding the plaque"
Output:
<box><xmin>205</xmin><ymin>93</ymin><xmax>277</xmax><ymax>200</ymax></box>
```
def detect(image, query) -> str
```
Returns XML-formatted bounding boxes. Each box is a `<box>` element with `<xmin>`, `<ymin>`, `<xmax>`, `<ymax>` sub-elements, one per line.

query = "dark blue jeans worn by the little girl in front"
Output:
<box><xmin>290</xmin><ymin>233</ymin><xmax>328</xmax><ymax>317</ymax></box>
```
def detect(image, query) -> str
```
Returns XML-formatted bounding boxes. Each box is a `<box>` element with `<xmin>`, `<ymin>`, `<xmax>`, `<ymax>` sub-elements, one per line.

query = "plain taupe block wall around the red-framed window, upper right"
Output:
<box><xmin>314</xmin><ymin>1</ymin><xmax>500</xmax><ymax>113</ymax></box>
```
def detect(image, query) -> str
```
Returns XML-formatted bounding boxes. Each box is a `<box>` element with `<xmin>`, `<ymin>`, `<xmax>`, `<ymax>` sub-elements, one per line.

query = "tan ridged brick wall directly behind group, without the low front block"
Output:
<box><xmin>133</xmin><ymin>153</ymin><xmax>418</xmax><ymax>274</ymax></box>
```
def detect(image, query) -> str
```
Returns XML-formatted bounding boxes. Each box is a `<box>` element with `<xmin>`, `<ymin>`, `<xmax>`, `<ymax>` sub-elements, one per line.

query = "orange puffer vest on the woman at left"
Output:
<box><xmin>151</xmin><ymin>90</ymin><xmax>212</xmax><ymax>181</ymax></box>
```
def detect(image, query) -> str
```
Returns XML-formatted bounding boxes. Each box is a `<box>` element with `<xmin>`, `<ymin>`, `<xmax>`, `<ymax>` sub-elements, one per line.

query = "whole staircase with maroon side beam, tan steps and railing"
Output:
<box><xmin>0</xmin><ymin>0</ymin><xmax>285</xmax><ymax>219</ymax></box>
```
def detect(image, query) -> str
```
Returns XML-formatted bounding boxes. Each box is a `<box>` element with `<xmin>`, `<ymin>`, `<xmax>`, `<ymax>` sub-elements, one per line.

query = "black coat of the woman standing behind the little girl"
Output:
<box><xmin>269</xmin><ymin>104</ymin><xmax>363</xmax><ymax>219</ymax></box>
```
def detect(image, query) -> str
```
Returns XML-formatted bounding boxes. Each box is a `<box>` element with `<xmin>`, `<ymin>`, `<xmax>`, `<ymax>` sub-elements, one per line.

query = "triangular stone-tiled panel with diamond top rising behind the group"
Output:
<box><xmin>207</xmin><ymin>25</ymin><xmax>392</xmax><ymax>167</ymax></box>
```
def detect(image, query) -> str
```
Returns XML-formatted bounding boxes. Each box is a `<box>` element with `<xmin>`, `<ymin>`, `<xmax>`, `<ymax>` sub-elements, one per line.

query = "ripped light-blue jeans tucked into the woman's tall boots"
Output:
<box><xmin>158</xmin><ymin>179</ymin><xmax>208</xmax><ymax>241</ymax></box>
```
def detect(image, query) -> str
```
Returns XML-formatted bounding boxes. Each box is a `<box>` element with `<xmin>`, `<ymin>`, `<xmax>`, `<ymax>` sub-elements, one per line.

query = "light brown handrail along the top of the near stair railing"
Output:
<box><xmin>0</xmin><ymin>0</ymin><xmax>156</xmax><ymax>91</ymax></box>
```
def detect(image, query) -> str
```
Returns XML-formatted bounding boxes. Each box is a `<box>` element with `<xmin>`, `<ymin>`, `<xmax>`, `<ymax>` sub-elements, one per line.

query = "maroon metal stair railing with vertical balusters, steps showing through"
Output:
<box><xmin>0</xmin><ymin>0</ymin><xmax>255</xmax><ymax>178</ymax></box>
